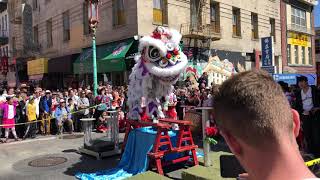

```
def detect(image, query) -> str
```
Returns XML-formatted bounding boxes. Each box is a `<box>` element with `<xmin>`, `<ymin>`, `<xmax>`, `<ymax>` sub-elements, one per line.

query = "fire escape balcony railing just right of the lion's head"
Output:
<box><xmin>180</xmin><ymin>23</ymin><xmax>221</xmax><ymax>41</ymax></box>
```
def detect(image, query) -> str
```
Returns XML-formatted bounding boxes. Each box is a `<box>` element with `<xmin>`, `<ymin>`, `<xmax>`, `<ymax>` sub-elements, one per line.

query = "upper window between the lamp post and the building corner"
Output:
<box><xmin>112</xmin><ymin>0</ymin><xmax>126</xmax><ymax>26</ymax></box>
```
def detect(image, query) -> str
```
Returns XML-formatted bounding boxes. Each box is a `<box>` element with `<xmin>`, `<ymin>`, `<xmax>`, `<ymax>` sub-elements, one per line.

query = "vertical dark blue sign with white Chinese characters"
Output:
<box><xmin>261</xmin><ymin>37</ymin><xmax>273</xmax><ymax>67</ymax></box>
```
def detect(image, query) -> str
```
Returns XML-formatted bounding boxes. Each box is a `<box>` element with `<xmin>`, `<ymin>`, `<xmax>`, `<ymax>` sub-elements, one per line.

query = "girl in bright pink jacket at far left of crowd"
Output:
<box><xmin>0</xmin><ymin>96</ymin><xmax>19</xmax><ymax>143</ymax></box>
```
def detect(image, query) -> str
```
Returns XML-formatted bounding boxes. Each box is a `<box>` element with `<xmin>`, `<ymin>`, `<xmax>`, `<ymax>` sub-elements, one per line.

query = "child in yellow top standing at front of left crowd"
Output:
<box><xmin>23</xmin><ymin>96</ymin><xmax>37</xmax><ymax>139</ymax></box>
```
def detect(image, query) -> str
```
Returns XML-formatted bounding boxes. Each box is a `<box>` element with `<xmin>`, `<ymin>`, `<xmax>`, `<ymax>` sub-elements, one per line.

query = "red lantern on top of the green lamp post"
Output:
<box><xmin>86</xmin><ymin>0</ymin><xmax>99</xmax><ymax>29</ymax></box>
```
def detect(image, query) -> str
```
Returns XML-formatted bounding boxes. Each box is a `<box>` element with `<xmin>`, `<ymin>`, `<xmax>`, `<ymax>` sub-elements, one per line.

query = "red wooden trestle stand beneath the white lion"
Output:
<box><xmin>122</xmin><ymin>119</ymin><xmax>199</xmax><ymax>175</ymax></box>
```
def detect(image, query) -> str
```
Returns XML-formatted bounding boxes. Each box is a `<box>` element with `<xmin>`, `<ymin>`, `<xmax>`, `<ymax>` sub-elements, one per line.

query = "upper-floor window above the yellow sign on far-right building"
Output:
<box><xmin>291</xmin><ymin>6</ymin><xmax>307</xmax><ymax>30</ymax></box>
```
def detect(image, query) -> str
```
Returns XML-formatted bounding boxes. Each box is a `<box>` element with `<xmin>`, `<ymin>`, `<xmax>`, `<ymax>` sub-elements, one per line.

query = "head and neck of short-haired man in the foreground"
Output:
<box><xmin>214</xmin><ymin>71</ymin><xmax>315</xmax><ymax>180</ymax></box>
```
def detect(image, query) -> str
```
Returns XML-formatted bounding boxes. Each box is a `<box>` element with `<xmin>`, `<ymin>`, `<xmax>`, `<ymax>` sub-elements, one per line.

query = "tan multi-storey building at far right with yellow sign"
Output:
<box><xmin>281</xmin><ymin>0</ymin><xmax>317</xmax><ymax>74</ymax></box>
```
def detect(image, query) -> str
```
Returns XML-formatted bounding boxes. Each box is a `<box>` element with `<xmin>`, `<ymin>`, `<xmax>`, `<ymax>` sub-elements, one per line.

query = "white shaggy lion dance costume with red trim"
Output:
<box><xmin>128</xmin><ymin>26</ymin><xmax>188</xmax><ymax>120</ymax></box>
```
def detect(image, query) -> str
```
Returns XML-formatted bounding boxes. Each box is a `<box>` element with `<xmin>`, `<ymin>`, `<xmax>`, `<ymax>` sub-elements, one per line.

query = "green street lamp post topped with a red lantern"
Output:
<box><xmin>86</xmin><ymin>0</ymin><xmax>99</xmax><ymax>96</ymax></box>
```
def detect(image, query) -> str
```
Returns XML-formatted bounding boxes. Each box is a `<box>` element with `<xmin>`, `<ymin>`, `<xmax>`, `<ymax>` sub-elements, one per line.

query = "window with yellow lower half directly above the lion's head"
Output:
<box><xmin>153</xmin><ymin>0</ymin><xmax>168</xmax><ymax>25</ymax></box>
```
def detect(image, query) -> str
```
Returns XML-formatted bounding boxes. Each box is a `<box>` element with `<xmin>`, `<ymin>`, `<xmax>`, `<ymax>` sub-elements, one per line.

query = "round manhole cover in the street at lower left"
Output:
<box><xmin>28</xmin><ymin>157</ymin><xmax>68</xmax><ymax>167</ymax></box>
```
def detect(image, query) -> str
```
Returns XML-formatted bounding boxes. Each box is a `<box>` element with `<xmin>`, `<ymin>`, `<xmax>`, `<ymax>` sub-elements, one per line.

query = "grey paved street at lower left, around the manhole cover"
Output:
<box><xmin>0</xmin><ymin>134</ymin><xmax>119</xmax><ymax>180</ymax></box>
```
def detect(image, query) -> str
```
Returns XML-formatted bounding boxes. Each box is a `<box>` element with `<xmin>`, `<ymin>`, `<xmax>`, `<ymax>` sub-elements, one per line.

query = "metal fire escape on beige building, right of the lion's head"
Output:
<box><xmin>180</xmin><ymin>0</ymin><xmax>221</xmax><ymax>60</ymax></box>
